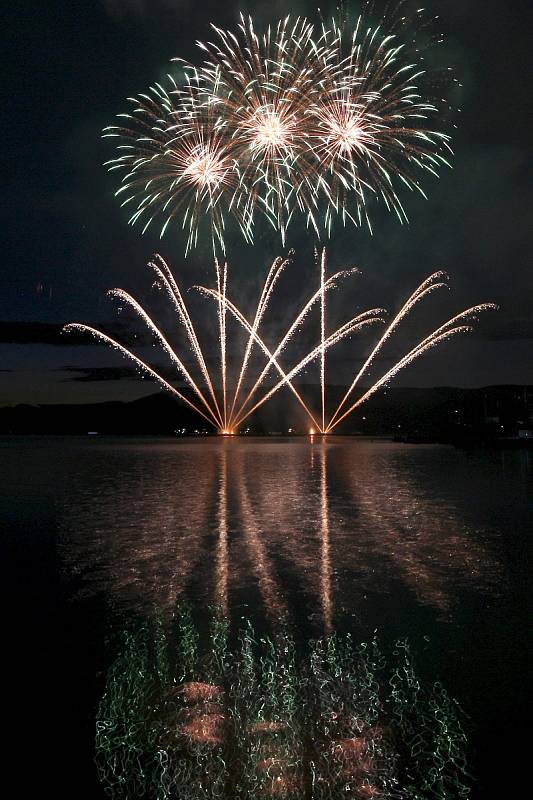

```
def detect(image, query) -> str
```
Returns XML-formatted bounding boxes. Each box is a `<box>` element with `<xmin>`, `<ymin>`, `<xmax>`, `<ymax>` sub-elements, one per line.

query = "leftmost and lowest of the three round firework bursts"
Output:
<box><xmin>104</xmin><ymin>78</ymin><xmax>249</xmax><ymax>249</ymax></box>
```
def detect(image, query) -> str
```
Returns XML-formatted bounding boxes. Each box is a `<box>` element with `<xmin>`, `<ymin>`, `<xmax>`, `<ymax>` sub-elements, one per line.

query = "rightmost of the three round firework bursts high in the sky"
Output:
<box><xmin>307</xmin><ymin>17</ymin><xmax>452</xmax><ymax>231</ymax></box>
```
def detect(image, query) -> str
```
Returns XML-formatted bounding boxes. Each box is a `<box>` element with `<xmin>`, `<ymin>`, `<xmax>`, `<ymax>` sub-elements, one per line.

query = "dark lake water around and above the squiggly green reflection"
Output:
<box><xmin>0</xmin><ymin>437</ymin><xmax>533</xmax><ymax>798</ymax></box>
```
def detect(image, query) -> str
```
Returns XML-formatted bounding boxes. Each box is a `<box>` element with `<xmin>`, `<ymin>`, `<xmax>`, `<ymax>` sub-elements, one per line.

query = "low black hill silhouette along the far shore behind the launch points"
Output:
<box><xmin>0</xmin><ymin>385</ymin><xmax>533</xmax><ymax>441</ymax></box>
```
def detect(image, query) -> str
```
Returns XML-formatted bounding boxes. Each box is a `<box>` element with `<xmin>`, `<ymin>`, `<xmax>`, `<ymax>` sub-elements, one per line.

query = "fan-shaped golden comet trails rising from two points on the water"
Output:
<box><xmin>66</xmin><ymin>251</ymin><xmax>495</xmax><ymax>434</ymax></box>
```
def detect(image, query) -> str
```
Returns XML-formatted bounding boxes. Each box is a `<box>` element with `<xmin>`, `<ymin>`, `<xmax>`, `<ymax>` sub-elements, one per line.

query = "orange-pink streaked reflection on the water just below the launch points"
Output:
<box><xmin>59</xmin><ymin>437</ymin><xmax>501</xmax><ymax>631</ymax></box>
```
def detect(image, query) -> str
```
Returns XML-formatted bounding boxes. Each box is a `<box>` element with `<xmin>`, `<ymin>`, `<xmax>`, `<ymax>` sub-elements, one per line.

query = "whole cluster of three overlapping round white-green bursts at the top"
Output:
<box><xmin>104</xmin><ymin>4</ymin><xmax>451</xmax><ymax>250</ymax></box>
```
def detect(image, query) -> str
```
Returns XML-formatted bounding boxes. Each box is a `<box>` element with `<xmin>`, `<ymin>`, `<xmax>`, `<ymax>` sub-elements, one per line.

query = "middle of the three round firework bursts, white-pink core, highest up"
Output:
<box><xmin>193</xmin><ymin>17</ymin><xmax>337</xmax><ymax>238</ymax></box>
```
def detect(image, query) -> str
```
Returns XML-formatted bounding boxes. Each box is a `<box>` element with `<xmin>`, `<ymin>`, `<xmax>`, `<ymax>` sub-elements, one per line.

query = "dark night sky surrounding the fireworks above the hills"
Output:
<box><xmin>0</xmin><ymin>0</ymin><xmax>533</xmax><ymax>405</ymax></box>
